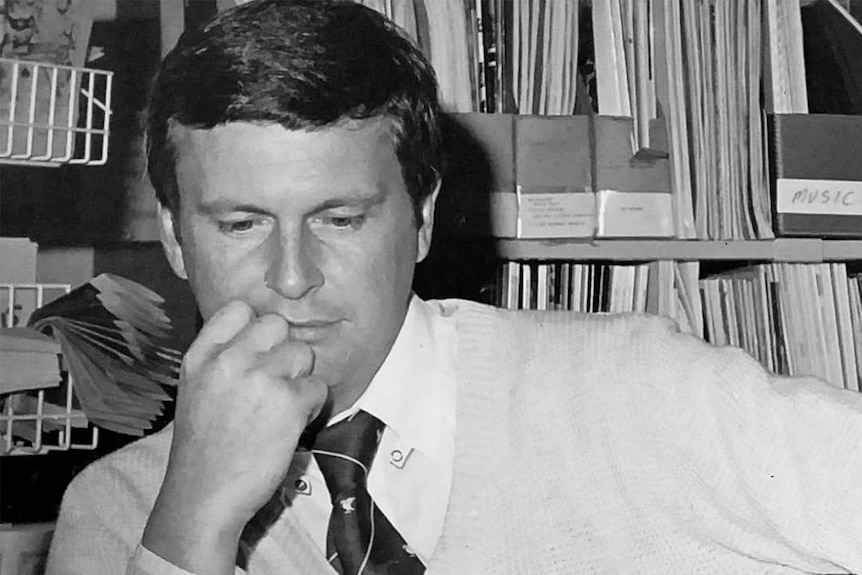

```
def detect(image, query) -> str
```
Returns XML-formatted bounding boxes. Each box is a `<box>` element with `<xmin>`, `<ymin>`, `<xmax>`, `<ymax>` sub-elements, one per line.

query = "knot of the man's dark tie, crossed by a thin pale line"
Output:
<box><xmin>312</xmin><ymin>411</ymin><xmax>384</xmax><ymax>500</ymax></box>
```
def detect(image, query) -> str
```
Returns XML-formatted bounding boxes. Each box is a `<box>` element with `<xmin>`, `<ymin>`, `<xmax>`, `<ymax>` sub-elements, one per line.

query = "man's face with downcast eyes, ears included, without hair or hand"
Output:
<box><xmin>161</xmin><ymin>120</ymin><xmax>434</xmax><ymax>409</ymax></box>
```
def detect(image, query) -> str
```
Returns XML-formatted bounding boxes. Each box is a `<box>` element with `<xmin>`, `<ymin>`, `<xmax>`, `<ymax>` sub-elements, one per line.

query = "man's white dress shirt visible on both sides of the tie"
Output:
<box><xmin>282</xmin><ymin>296</ymin><xmax>455</xmax><ymax>561</ymax></box>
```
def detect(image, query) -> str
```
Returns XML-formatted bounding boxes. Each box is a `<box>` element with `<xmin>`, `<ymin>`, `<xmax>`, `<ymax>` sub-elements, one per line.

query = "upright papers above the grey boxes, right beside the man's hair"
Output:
<box><xmin>357</xmin><ymin>0</ymin><xmax>580</xmax><ymax>115</ymax></box>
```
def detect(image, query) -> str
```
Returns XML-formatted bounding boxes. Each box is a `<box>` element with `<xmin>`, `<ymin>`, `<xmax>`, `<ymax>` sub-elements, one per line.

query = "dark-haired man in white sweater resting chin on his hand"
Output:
<box><xmin>48</xmin><ymin>0</ymin><xmax>862</xmax><ymax>575</ymax></box>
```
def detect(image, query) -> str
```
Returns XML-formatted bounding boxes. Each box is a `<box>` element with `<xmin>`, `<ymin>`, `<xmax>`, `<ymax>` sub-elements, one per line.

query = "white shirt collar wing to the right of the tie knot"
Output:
<box><xmin>330</xmin><ymin>295</ymin><xmax>454</xmax><ymax>458</ymax></box>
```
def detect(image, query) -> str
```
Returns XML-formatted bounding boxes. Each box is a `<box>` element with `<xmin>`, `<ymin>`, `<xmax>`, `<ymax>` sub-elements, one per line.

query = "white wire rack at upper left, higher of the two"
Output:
<box><xmin>0</xmin><ymin>58</ymin><xmax>113</xmax><ymax>166</ymax></box>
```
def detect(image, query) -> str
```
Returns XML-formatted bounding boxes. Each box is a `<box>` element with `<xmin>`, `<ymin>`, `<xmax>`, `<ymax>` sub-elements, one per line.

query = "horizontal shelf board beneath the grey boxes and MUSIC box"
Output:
<box><xmin>496</xmin><ymin>238</ymin><xmax>862</xmax><ymax>262</ymax></box>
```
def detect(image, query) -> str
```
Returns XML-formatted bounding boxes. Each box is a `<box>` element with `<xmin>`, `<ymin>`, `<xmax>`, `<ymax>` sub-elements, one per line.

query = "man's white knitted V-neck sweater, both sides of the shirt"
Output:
<box><xmin>48</xmin><ymin>300</ymin><xmax>862</xmax><ymax>575</ymax></box>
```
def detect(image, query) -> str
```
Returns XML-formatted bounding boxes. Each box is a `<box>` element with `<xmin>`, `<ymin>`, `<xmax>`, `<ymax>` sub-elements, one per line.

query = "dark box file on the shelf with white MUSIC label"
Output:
<box><xmin>767</xmin><ymin>114</ymin><xmax>862</xmax><ymax>238</ymax></box>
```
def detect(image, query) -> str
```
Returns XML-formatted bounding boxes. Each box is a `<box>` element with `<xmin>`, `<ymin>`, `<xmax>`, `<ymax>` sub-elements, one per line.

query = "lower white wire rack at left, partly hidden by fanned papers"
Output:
<box><xmin>0</xmin><ymin>284</ymin><xmax>99</xmax><ymax>455</ymax></box>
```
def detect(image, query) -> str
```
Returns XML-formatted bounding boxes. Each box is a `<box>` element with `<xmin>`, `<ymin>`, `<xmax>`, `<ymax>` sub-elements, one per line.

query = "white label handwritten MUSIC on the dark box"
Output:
<box><xmin>775</xmin><ymin>178</ymin><xmax>862</xmax><ymax>216</ymax></box>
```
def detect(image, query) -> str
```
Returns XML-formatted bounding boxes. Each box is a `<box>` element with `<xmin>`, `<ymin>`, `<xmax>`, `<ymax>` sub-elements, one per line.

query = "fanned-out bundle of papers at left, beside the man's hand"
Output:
<box><xmin>30</xmin><ymin>274</ymin><xmax>180</xmax><ymax>435</ymax></box>
